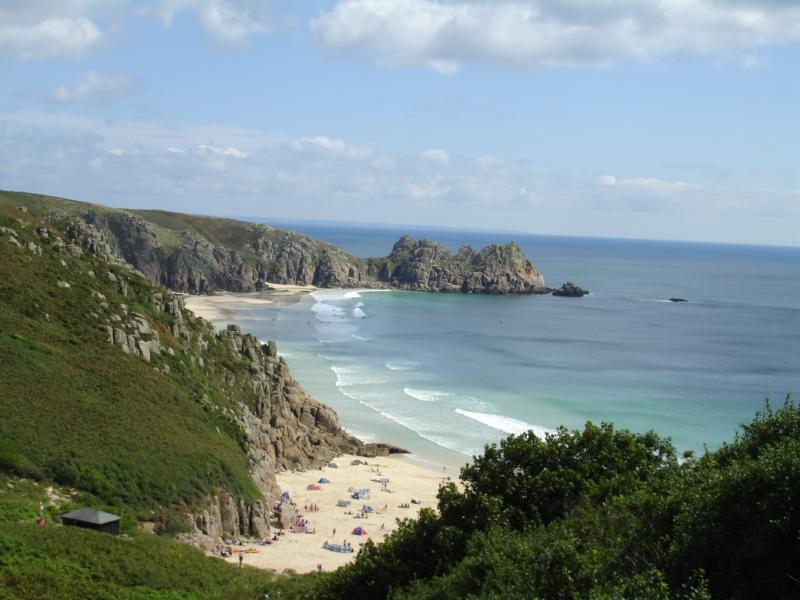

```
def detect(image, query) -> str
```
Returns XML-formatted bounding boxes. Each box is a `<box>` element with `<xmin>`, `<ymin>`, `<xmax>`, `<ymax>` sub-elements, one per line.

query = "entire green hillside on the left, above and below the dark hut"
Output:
<box><xmin>0</xmin><ymin>195</ymin><xmax>346</xmax><ymax>599</ymax></box>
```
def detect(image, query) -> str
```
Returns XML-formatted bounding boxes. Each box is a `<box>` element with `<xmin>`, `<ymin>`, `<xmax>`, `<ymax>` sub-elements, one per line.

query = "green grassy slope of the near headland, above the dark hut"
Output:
<box><xmin>0</xmin><ymin>204</ymin><xmax>257</xmax><ymax>509</ymax></box>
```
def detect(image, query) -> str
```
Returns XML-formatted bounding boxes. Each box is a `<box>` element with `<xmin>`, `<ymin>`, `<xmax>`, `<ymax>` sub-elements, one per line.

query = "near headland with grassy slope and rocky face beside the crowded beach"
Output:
<box><xmin>0</xmin><ymin>197</ymin><xmax>397</xmax><ymax>546</ymax></box>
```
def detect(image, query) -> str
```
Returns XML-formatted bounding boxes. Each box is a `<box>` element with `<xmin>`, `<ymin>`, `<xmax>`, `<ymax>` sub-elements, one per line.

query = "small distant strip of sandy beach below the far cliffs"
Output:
<box><xmin>183</xmin><ymin>283</ymin><xmax>318</xmax><ymax>323</ymax></box>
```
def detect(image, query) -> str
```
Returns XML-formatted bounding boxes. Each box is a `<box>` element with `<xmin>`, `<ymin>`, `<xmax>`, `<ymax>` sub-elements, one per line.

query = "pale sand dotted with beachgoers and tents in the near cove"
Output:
<box><xmin>216</xmin><ymin>455</ymin><xmax>454</xmax><ymax>573</ymax></box>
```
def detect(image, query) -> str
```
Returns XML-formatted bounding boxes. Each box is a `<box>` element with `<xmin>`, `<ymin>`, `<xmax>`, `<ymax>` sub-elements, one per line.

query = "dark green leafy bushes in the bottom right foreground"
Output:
<box><xmin>299</xmin><ymin>399</ymin><xmax>800</xmax><ymax>600</ymax></box>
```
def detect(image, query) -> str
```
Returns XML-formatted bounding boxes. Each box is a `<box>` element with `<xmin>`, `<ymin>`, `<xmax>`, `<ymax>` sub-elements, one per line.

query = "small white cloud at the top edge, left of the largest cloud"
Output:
<box><xmin>158</xmin><ymin>0</ymin><xmax>272</xmax><ymax>46</ymax></box>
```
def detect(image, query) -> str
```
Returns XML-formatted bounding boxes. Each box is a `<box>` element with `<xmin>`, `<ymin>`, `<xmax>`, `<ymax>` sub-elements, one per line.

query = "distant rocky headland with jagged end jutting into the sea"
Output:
<box><xmin>3</xmin><ymin>193</ymin><xmax>548</xmax><ymax>294</ymax></box>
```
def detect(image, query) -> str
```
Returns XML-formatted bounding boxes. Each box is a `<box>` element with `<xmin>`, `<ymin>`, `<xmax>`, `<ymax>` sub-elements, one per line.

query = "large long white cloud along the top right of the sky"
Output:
<box><xmin>310</xmin><ymin>0</ymin><xmax>800</xmax><ymax>73</ymax></box>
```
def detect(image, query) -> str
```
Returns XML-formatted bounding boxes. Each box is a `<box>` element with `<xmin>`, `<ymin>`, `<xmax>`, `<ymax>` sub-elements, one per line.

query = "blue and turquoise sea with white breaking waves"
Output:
<box><xmin>222</xmin><ymin>222</ymin><xmax>800</xmax><ymax>465</ymax></box>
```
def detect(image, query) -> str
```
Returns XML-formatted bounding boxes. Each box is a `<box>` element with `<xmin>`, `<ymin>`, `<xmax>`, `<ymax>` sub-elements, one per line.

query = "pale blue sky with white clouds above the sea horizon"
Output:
<box><xmin>0</xmin><ymin>0</ymin><xmax>800</xmax><ymax>246</ymax></box>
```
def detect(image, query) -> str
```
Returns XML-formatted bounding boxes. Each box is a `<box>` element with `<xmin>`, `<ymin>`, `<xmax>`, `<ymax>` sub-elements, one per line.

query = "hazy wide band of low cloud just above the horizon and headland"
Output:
<box><xmin>0</xmin><ymin>111</ymin><xmax>800</xmax><ymax>245</ymax></box>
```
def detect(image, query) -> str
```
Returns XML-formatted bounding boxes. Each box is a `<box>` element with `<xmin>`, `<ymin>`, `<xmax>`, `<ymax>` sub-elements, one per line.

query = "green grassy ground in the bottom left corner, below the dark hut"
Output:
<box><xmin>0</xmin><ymin>474</ymin><xmax>282</xmax><ymax>600</ymax></box>
